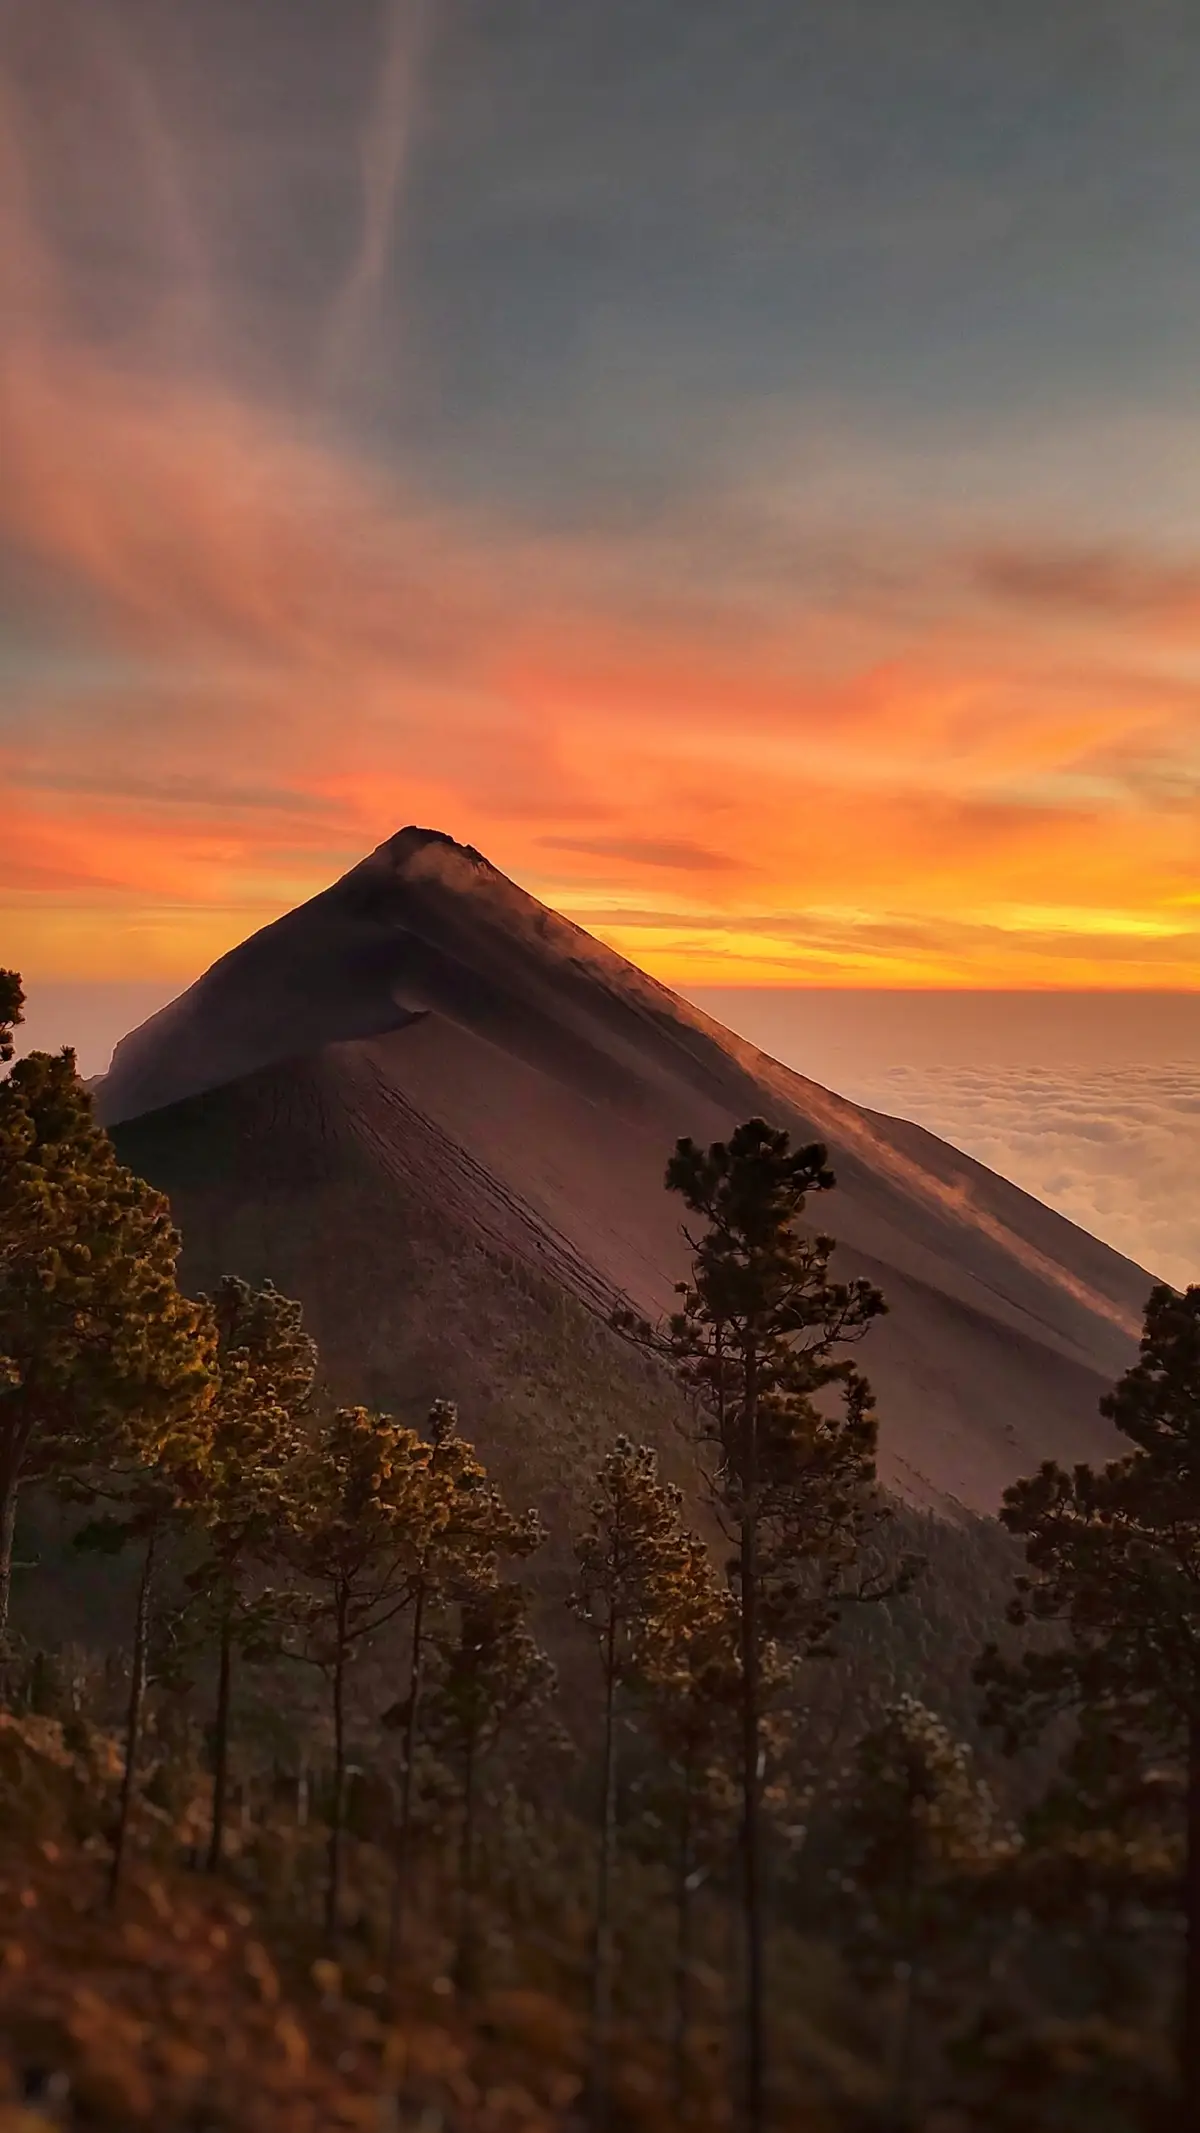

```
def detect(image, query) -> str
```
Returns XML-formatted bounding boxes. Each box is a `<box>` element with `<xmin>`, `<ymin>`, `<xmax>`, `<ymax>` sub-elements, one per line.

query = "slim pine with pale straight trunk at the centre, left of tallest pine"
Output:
<box><xmin>569</xmin><ymin>1436</ymin><xmax>691</xmax><ymax>2127</ymax></box>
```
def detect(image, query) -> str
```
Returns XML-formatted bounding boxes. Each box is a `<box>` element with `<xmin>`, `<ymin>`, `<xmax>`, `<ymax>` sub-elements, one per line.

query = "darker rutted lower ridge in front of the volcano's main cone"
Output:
<box><xmin>115</xmin><ymin>1062</ymin><xmax>695</xmax><ymax>1578</ymax></box>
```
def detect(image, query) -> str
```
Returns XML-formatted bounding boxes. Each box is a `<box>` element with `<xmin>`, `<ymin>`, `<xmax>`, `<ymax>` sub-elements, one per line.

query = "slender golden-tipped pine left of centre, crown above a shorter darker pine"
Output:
<box><xmin>384</xmin><ymin>1399</ymin><xmax>544</xmax><ymax>1973</ymax></box>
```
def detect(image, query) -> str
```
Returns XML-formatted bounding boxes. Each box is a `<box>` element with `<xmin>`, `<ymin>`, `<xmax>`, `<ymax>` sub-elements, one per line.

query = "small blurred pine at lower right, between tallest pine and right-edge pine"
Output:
<box><xmin>840</xmin><ymin>1696</ymin><xmax>1017</xmax><ymax>2124</ymax></box>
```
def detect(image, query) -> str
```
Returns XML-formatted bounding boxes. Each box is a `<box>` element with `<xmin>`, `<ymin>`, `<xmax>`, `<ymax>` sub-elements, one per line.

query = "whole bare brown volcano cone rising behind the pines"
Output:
<box><xmin>98</xmin><ymin>830</ymin><xmax>1149</xmax><ymax>1523</ymax></box>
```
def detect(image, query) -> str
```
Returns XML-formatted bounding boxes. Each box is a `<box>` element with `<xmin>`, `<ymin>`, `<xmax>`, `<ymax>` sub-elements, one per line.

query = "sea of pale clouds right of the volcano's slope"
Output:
<box><xmin>842</xmin><ymin>1062</ymin><xmax>1200</xmax><ymax>1286</ymax></box>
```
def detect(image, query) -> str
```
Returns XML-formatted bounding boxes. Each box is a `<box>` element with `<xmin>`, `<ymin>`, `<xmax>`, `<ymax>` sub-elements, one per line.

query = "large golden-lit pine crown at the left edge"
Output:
<box><xmin>0</xmin><ymin>1052</ymin><xmax>211</xmax><ymax>1634</ymax></box>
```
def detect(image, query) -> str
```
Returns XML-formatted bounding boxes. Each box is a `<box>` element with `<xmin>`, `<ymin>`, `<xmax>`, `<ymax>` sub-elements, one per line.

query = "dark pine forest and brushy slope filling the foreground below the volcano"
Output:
<box><xmin>0</xmin><ymin>973</ymin><xmax>1200</xmax><ymax>2133</ymax></box>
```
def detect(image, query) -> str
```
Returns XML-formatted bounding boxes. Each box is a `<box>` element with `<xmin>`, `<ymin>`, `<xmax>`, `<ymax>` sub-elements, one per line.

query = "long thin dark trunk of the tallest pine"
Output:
<box><xmin>740</xmin><ymin>1346</ymin><xmax>765</xmax><ymax>2133</ymax></box>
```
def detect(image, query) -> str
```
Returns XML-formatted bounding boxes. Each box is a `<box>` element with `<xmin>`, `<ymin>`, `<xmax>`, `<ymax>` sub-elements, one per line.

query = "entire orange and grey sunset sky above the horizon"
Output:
<box><xmin>0</xmin><ymin>0</ymin><xmax>1200</xmax><ymax>992</ymax></box>
